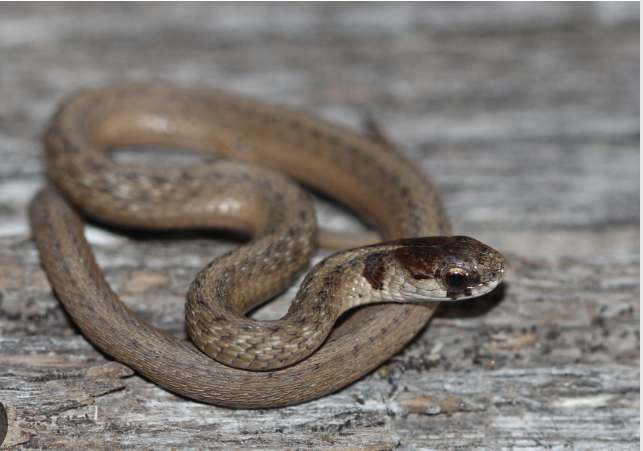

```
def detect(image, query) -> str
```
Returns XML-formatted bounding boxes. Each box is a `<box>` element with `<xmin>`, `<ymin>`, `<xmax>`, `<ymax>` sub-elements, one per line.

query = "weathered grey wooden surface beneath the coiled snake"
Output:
<box><xmin>0</xmin><ymin>3</ymin><xmax>640</xmax><ymax>451</ymax></box>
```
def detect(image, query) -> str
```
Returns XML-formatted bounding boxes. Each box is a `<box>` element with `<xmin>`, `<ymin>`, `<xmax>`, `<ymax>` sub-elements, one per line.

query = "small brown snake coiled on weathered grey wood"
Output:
<box><xmin>29</xmin><ymin>82</ymin><xmax>505</xmax><ymax>408</ymax></box>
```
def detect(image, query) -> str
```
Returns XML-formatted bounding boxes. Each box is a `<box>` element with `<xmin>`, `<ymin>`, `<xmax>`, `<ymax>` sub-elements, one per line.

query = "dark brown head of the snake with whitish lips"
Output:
<box><xmin>364</xmin><ymin>236</ymin><xmax>505</xmax><ymax>301</ymax></box>
